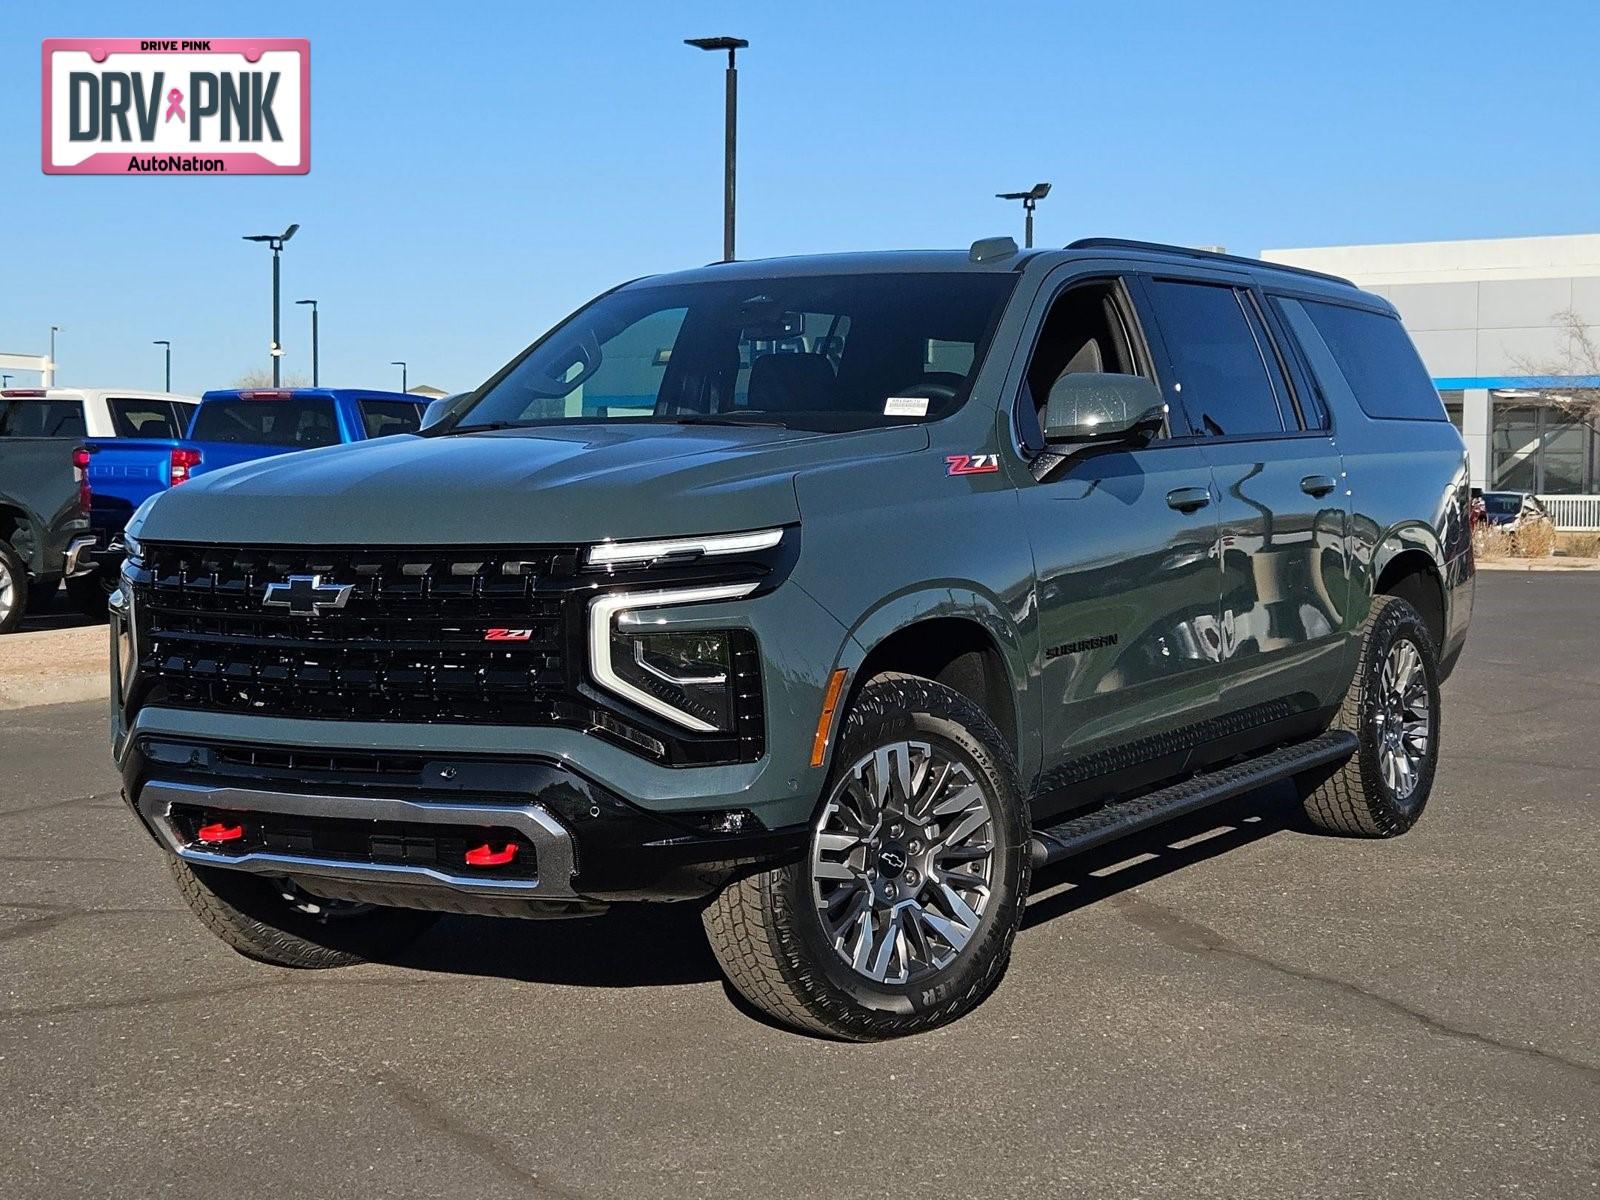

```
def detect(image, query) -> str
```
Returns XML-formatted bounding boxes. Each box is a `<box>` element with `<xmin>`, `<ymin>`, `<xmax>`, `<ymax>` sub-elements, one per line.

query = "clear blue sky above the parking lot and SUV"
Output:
<box><xmin>0</xmin><ymin>0</ymin><xmax>1600</xmax><ymax>392</ymax></box>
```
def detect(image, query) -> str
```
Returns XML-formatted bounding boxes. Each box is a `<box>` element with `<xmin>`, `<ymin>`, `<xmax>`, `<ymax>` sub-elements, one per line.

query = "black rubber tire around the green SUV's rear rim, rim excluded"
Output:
<box><xmin>1298</xmin><ymin>595</ymin><xmax>1440</xmax><ymax>837</ymax></box>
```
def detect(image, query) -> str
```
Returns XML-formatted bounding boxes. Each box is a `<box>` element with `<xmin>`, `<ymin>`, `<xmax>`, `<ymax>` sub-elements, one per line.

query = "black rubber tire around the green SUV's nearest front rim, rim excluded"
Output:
<box><xmin>704</xmin><ymin>674</ymin><xmax>1032</xmax><ymax>1042</ymax></box>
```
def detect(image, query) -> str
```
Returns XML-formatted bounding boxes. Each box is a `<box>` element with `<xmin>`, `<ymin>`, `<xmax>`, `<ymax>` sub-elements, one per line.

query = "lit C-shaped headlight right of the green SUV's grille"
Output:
<box><xmin>589</xmin><ymin>582</ymin><xmax>758</xmax><ymax>733</ymax></box>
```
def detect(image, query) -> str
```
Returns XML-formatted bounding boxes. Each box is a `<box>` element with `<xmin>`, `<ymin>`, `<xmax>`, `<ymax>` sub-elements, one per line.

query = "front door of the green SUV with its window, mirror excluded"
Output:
<box><xmin>1018</xmin><ymin>278</ymin><xmax>1221</xmax><ymax>816</ymax></box>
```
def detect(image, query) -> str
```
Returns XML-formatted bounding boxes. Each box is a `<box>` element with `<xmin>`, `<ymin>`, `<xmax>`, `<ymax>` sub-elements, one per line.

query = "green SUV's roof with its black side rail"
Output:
<box><xmin>635</xmin><ymin>237</ymin><xmax>1373</xmax><ymax>299</ymax></box>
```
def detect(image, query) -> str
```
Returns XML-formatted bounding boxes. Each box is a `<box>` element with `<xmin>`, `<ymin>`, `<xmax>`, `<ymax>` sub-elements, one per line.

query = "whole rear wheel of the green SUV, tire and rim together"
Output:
<box><xmin>1301</xmin><ymin>595</ymin><xmax>1440</xmax><ymax>837</ymax></box>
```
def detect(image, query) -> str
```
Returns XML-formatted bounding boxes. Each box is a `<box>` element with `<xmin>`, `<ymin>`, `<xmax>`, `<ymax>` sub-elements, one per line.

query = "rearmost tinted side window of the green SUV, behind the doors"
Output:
<box><xmin>1285</xmin><ymin>301</ymin><xmax>1448</xmax><ymax>421</ymax></box>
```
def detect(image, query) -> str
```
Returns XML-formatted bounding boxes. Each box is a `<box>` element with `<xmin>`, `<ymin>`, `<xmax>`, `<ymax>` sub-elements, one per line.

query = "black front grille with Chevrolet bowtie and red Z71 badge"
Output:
<box><xmin>136</xmin><ymin>546</ymin><xmax>584</xmax><ymax>725</ymax></box>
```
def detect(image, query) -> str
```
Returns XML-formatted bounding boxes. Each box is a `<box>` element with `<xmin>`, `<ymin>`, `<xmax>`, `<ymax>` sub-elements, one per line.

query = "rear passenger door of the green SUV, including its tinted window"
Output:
<box><xmin>1146</xmin><ymin>274</ymin><xmax>1349</xmax><ymax>713</ymax></box>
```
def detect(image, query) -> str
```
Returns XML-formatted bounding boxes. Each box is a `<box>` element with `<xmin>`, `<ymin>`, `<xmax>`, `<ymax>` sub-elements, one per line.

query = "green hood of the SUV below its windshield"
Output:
<box><xmin>141</xmin><ymin>422</ymin><xmax>928</xmax><ymax>546</ymax></box>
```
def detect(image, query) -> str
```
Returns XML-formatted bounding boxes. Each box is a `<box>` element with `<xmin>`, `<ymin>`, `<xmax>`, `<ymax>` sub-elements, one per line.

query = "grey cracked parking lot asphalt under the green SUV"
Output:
<box><xmin>0</xmin><ymin>573</ymin><xmax>1600</xmax><ymax>1200</ymax></box>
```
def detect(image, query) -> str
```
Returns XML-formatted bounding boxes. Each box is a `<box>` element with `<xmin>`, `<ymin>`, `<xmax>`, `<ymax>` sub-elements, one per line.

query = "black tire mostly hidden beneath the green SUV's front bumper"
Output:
<box><xmin>166</xmin><ymin>854</ymin><xmax>438</xmax><ymax>970</ymax></box>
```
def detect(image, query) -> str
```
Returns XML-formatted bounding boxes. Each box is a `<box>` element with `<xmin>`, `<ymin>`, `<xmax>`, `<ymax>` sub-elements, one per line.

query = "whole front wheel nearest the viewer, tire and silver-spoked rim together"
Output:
<box><xmin>704</xmin><ymin>675</ymin><xmax>1029</xmax><ymax>1042</ymax></box>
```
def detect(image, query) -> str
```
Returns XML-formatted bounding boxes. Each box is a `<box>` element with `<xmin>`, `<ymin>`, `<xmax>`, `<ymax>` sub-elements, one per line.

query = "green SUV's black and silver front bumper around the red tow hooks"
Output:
<box><xmin>123</xmin><ymin>738</ymin><xmax>806</xmax><ymax>915</ymax></box>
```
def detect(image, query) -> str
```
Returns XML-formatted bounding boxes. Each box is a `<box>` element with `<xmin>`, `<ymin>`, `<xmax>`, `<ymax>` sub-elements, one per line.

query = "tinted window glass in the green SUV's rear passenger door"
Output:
<box><xmin>1149</xmin><ymin>280</ymin><xmax>1283</xmax><ymax>437</ymax></box>
